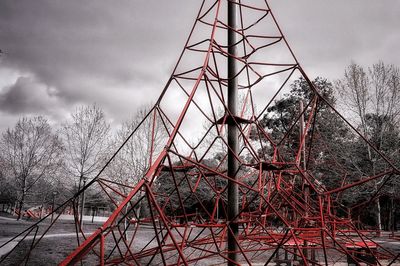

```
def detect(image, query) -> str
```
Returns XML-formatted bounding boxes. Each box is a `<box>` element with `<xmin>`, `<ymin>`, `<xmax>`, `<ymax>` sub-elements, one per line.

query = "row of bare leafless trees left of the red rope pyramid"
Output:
<box><xmin>0</xmin><ymin>104</ymin><xmax>159</xmax><ymax>219</ymax></box>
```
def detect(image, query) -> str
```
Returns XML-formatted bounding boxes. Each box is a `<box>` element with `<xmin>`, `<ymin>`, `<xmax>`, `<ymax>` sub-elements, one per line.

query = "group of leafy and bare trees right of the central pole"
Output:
<box><xmin>262</xmin><ymin>62</ymin><xmax>400</xmax><ymax>230</ymax></box>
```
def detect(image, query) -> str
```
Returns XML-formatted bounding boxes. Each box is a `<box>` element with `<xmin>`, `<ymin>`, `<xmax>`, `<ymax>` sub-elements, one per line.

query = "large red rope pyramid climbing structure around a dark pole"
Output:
<box><xmin>1</xmin><ymin>0</ymin><xmax>399</xmax><ymax>265</ymax></box>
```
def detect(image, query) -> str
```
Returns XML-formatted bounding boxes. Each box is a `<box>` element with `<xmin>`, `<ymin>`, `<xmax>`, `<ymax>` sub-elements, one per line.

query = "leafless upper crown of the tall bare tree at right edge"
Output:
<box><xmin>336</xmin><ymin>62</ymin><xmax>400</xmax><ymax>141</ymax></box>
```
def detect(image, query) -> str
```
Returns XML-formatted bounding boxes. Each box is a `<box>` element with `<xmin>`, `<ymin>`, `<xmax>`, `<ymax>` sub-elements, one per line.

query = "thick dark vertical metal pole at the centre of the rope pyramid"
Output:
<box><xmin>227</xmin><ymin>0</ymin><xmax>239</xmax><ymax>265</ymax></box>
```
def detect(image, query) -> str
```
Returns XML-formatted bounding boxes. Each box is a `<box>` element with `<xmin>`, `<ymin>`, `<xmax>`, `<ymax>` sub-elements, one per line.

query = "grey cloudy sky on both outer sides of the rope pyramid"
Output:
<box><xmin>0</xmin><ymin>0</ymin><xmax>400</xmax><ymax>131</ymax></box>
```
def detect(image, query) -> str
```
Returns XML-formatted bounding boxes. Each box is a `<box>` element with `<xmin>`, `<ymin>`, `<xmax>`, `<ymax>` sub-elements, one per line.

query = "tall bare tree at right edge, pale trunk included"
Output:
<box><xmin>336</xmin><ymin>62</ymin><xmax>400</xmax><ymax>229</ymax></box>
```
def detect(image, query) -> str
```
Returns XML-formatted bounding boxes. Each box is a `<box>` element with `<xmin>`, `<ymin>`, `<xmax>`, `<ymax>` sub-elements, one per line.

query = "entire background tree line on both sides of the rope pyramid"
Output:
<box><xmin>0</xmin><ymin>62</ymin><xmax>400</xmax><ymax>229</ymax></box>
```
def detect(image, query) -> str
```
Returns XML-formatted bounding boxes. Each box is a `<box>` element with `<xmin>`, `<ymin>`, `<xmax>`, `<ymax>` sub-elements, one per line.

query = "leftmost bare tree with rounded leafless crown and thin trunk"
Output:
<box><xmin>0</xmin><ymin>116</ymin><xmax>62</xmax><ymax>219</ymax></box>
